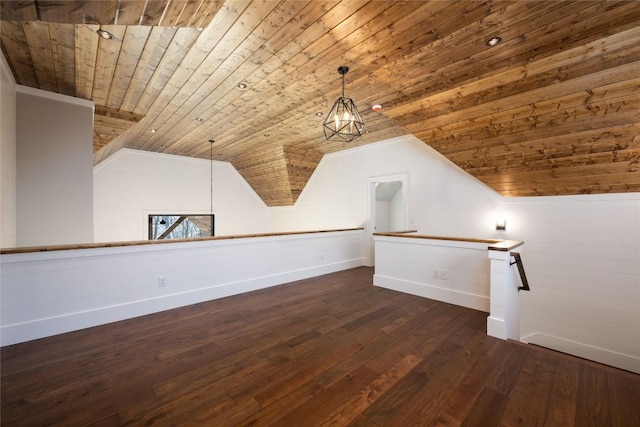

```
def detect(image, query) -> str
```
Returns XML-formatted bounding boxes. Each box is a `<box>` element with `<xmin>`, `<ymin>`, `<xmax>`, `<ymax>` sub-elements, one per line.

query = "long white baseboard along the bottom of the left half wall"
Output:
<box><xmin>0</xmin><ymin>258</ymin><xmax>364</xmax><ymax>346</ymax></box>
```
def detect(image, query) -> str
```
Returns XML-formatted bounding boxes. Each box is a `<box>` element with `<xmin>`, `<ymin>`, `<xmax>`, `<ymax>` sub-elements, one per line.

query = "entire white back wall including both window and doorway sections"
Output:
<box><xmin>94</xmin><ymin>136</ymin><xmax>501</xmax><ymax>242</ymax></box>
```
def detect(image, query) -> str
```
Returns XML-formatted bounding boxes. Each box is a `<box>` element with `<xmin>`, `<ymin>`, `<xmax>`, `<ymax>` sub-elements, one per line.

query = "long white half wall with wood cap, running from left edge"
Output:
<box><xmin>0</xmin><ymin>230</ymin><xmax>364</xmax><ymax>345</ymax></box>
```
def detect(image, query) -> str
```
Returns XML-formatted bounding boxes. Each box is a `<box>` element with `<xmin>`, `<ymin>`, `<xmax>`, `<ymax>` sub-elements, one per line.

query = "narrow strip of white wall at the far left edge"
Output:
<box><xmin>0</xmin><ymin>53</ymin><xmax>16</xmax><ymax>248</ymax></box>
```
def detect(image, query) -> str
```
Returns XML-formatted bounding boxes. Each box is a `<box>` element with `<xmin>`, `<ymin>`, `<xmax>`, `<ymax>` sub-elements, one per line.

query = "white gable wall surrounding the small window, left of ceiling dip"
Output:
<box><xmin>94</xmin><ymin>149</ymin><xmax>269</xmax><ymax>242</ymax></box>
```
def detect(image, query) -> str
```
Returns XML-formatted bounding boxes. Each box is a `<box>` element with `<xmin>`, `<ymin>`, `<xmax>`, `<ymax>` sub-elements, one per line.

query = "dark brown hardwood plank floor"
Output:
<box><xmin>1</xmin><ymin>267</ymin><xmax>640</xmax><ymax>427</ymax></box>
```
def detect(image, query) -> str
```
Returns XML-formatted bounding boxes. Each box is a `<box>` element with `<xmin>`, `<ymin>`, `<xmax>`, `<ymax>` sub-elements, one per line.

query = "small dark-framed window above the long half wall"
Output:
<box><xmin>149</xmin><ymin>214</ymin><xmax>215</xmax><ymax>240</ymax></box>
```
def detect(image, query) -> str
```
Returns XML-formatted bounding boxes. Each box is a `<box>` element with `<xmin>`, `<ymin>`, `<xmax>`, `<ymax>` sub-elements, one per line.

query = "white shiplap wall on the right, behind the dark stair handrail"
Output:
<box><xmin>504</xmin><ymin>193</ymin><xmax>640</xmax><ymax>372</ymax></box>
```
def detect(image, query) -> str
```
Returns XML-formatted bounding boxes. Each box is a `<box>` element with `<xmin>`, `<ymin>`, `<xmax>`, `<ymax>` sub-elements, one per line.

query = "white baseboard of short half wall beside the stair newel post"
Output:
<box><xmin>373</xmin><ymin>274</ymin><xmax>489</xmax><ymax>313</ymax></box>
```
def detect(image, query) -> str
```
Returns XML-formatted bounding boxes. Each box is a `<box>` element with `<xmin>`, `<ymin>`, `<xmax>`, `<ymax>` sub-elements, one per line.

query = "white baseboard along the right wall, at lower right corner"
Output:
<box><xmin>520</xmin><ymin>332</ymin><xmax>640</xmax><ymax>374</ymax></box>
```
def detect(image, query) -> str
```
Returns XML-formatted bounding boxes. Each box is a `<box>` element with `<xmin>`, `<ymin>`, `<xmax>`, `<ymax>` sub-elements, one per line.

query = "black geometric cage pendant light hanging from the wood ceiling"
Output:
<box><xmin>322</xmin><ymin>66</ymin><xmax>364</xmax><ymax>142</ymax></box>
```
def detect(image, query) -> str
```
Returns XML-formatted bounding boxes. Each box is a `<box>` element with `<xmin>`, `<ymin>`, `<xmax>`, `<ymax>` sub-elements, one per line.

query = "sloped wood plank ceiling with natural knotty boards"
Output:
<box><xmin>0</xmin><ymin>0</ymin><xmax>640</xmax><ymax>206</ymax></box>
